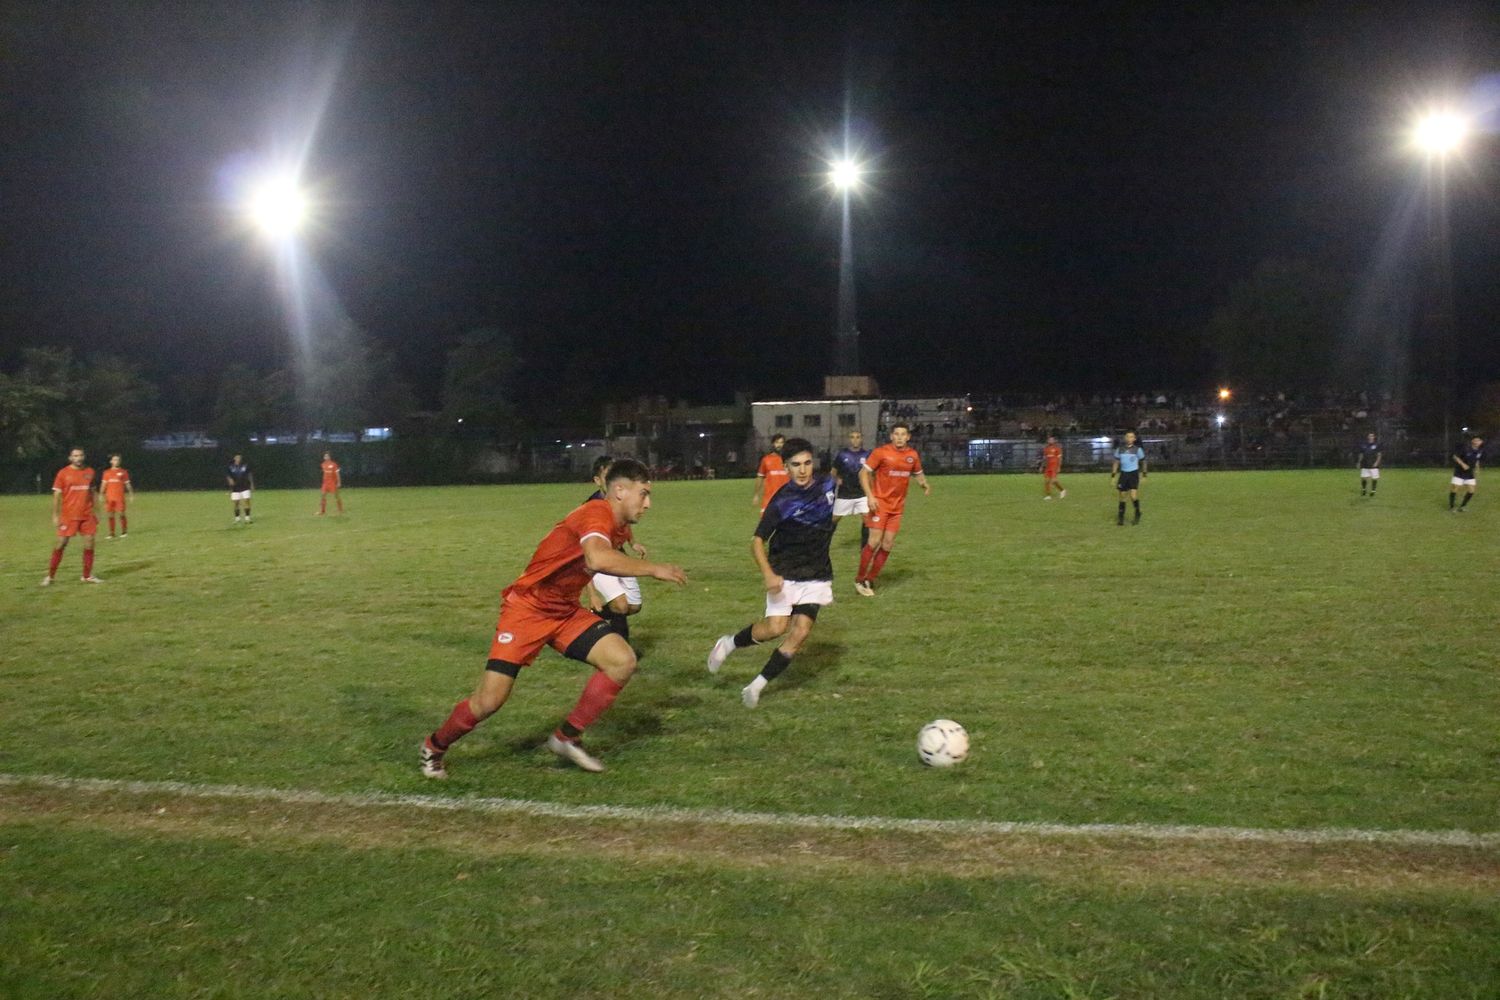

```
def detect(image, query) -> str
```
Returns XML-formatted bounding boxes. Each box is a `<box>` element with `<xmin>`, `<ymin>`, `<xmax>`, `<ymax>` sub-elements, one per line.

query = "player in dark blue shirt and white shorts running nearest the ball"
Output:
<box><xmin>708</xmin><ymin>438</ymin><xmax>834</xmax><ymax>708</ymax></box>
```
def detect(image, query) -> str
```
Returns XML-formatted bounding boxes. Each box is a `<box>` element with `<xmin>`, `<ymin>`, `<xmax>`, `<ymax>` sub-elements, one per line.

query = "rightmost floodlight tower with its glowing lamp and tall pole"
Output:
<box><xmin>1412</xmin><ymin>109</ymin><xmax>1472</xmax><ymax>445</ymax></box>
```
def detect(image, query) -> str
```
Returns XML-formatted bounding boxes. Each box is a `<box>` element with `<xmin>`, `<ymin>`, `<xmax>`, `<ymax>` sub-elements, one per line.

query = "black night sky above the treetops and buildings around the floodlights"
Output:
<box><xmin>0</xmin><ymin>3</ymin><xmax>1500</xmax><ymax>405</ymax></box>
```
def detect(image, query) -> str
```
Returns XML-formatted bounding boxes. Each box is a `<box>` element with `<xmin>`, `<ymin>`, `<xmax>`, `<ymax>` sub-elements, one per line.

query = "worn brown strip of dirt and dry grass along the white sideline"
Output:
<box><xmin>0</xmin><ymin>786</ymin><xmax>1500</xmax><ymax>895</ymax></box>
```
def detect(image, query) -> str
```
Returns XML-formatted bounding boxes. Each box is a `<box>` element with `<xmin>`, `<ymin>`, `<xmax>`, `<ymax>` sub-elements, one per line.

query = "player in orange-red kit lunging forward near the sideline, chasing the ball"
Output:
<box><xmin>422</xmin><ymin>459</ymin><xmax>687</xmax><ymax>778</ymax></box>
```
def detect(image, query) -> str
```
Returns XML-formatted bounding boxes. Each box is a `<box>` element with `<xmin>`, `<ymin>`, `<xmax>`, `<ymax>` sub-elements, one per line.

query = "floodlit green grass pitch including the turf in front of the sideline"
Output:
<box><xmin>0</xmin><ymin>471</ymin><xmax>1500</xmax><ymax>999</ymax></box>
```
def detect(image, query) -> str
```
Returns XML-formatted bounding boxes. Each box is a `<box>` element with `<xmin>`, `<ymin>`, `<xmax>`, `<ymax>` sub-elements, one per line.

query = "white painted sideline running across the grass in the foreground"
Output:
<box><xmin>0</xmin><ymin>774</ymin><xmax>1500</xmax><ymax>850</ymax></box>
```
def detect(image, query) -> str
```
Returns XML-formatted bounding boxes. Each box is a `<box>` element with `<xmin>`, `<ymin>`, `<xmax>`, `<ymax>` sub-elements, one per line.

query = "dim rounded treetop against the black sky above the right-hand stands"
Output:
<box><xmin>1208</xmin><ymin>259</ymin><xmax>1349</xmax><ymax>390</ymax></box>
